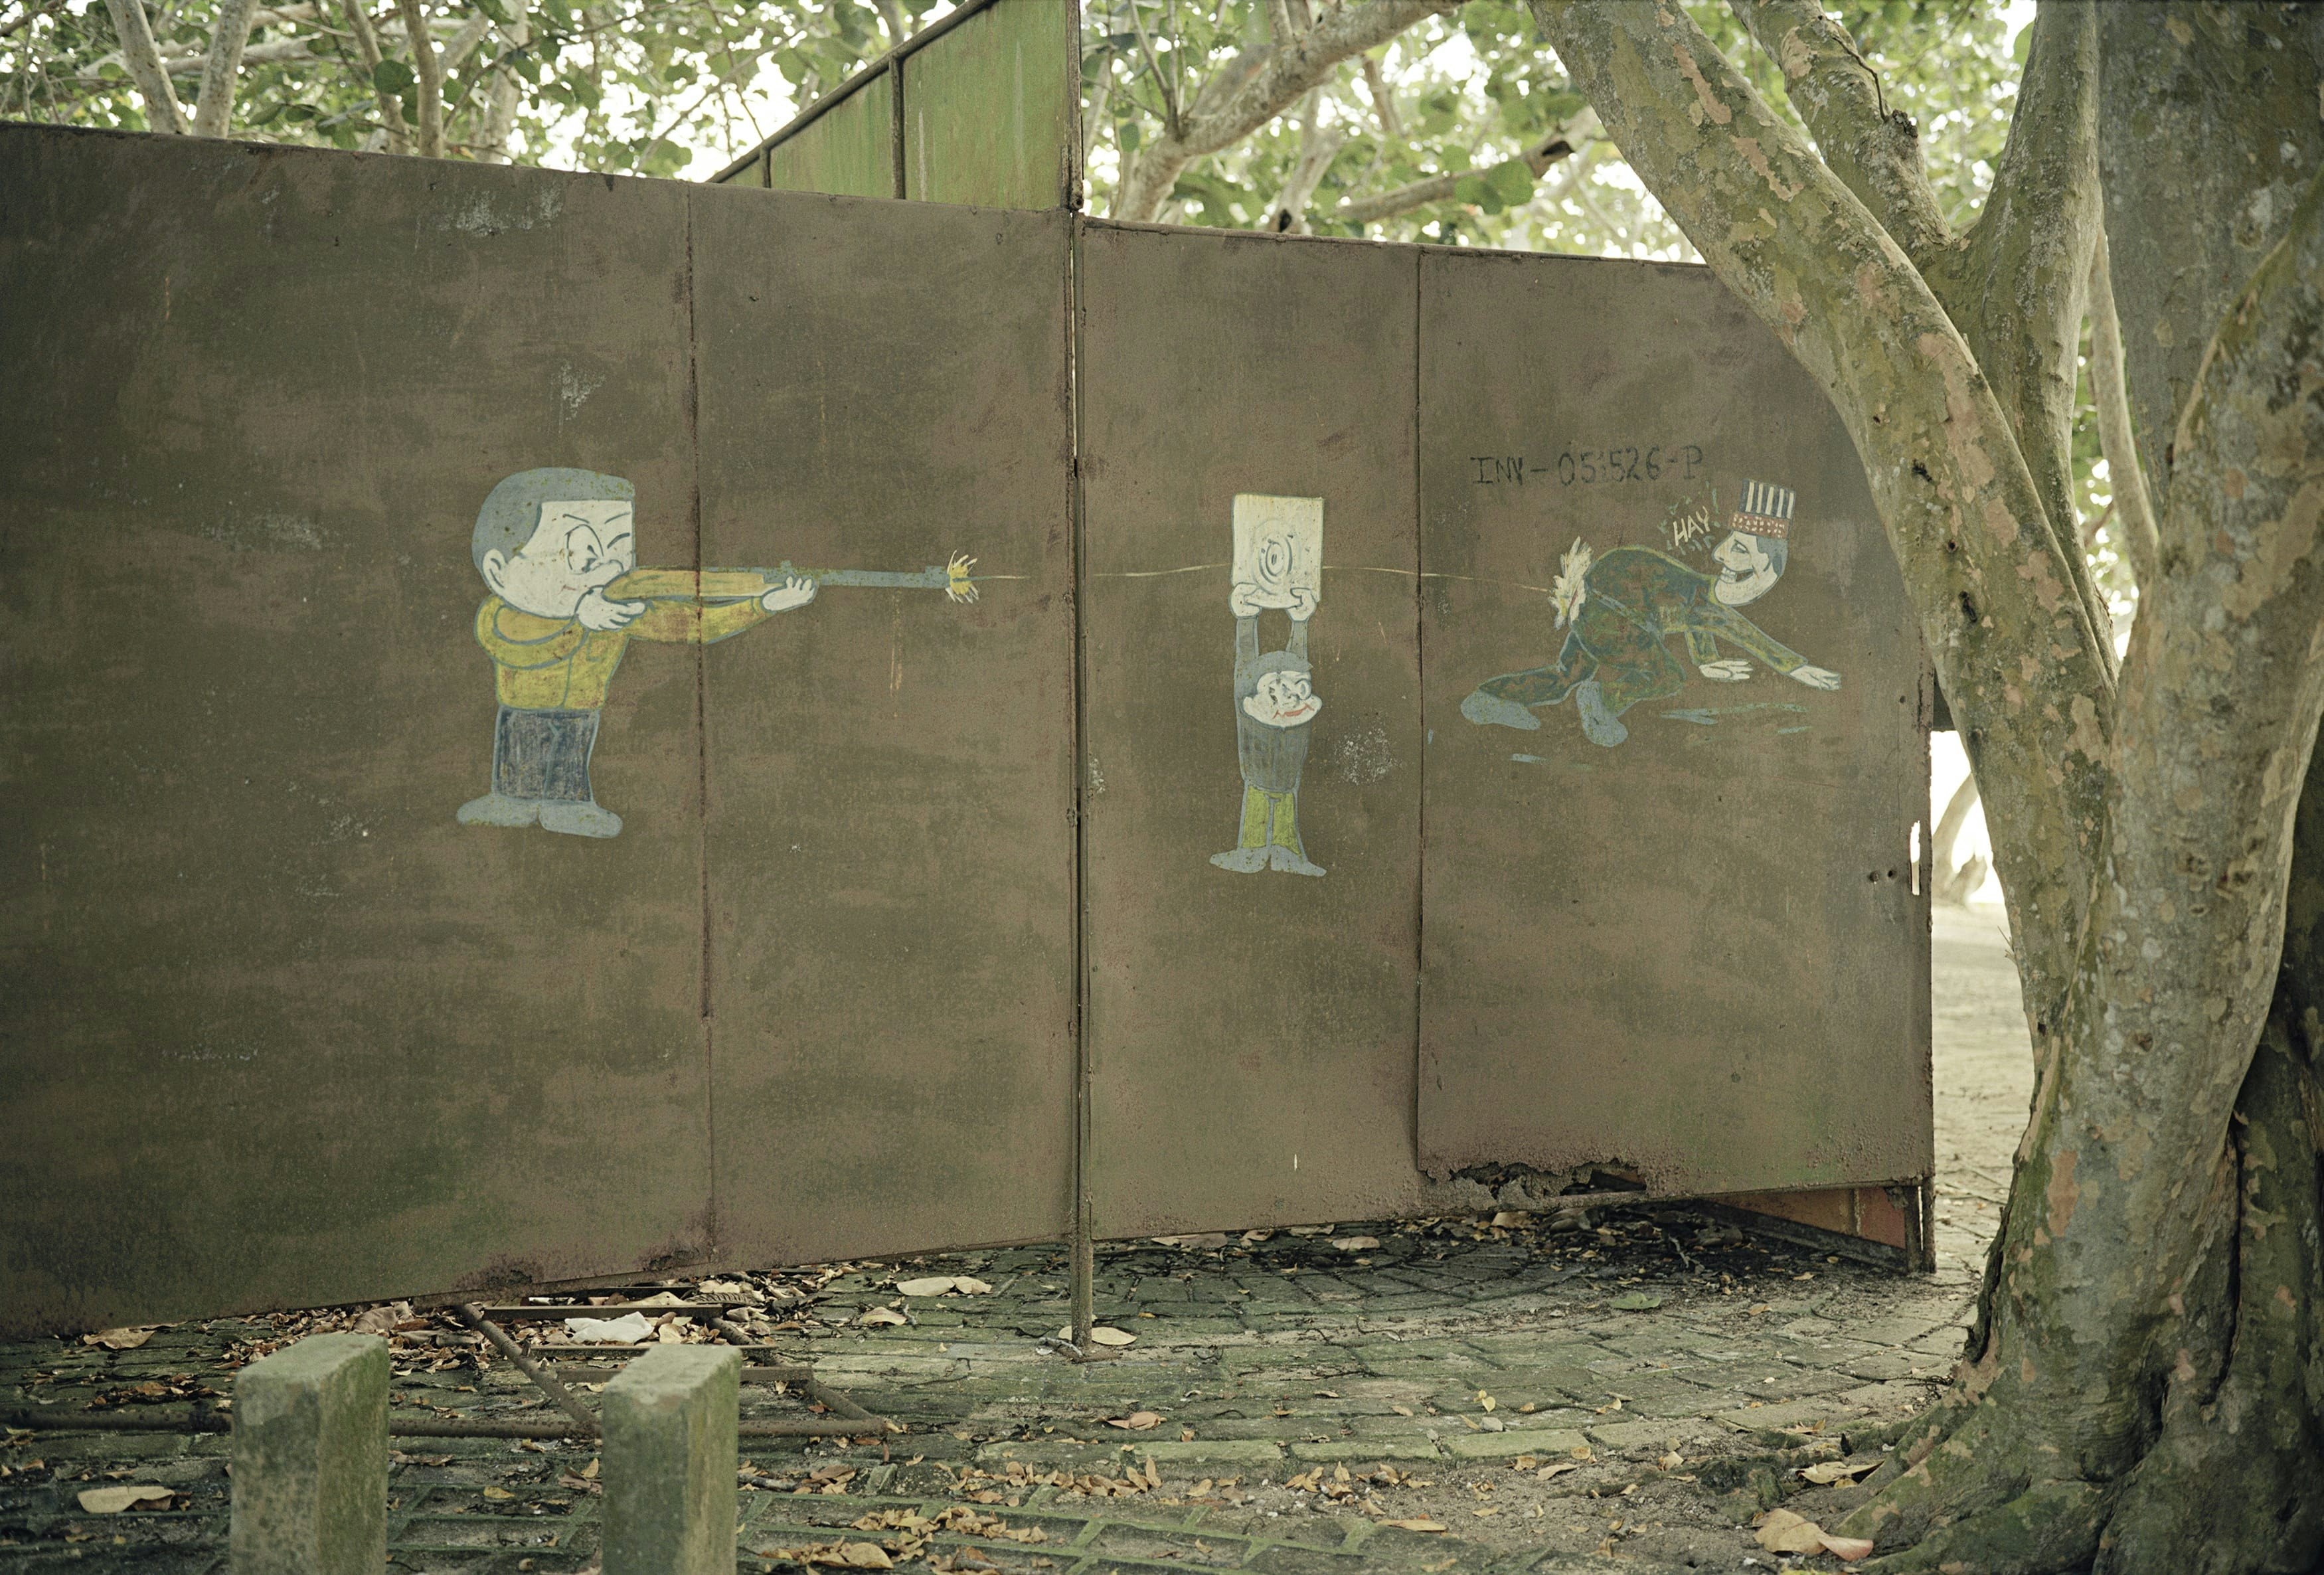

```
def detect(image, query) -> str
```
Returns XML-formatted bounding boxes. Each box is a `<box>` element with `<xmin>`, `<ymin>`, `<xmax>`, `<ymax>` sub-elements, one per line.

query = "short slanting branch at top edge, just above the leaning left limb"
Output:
<box><xmin>1729</xmin><ymin>0</ymin><xmax>1955</xmax><ymax>272</ymax></box>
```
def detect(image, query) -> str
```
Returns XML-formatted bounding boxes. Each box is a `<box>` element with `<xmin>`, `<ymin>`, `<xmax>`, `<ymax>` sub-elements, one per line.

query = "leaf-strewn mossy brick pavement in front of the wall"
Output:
<box><xmin>0</xmin><ymin>915</ymin><xmax>2029</xmax><ymax>1575</ymax></box>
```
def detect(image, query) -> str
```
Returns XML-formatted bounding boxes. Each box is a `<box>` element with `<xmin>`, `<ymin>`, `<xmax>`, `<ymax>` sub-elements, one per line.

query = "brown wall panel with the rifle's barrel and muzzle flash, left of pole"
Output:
<box><xmin>695</xmin><ymin>191</ymin><xmax>1076</xmax><ymax>1262</ymax></box>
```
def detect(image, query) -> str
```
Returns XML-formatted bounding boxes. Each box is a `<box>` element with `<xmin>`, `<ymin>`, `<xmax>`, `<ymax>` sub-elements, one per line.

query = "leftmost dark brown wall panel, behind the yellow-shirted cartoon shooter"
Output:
<box><xmin>0</xmin><ymin>127</ymin><xmax>709</xmax><ymax>1333</ymax></box>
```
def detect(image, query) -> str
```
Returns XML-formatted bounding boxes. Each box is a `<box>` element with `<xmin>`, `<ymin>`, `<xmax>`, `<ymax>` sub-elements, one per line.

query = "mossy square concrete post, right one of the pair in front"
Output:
<box><xmin>602</xmin><ymin>1345</ymin><xmax>742</xmax><ymax>1575</ymax></box>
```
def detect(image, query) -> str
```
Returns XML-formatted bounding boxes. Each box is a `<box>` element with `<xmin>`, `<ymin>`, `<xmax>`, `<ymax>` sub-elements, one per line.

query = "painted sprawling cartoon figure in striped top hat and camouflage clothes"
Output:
<box><xmin>1459</xmin><ymin>481</ymin><xmax>1841</xmax><ymax>748</ymax></box>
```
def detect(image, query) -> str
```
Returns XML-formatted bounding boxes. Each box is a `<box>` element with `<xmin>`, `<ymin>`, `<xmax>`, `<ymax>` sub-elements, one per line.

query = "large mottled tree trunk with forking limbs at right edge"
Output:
<box><xmin>1536</xmin><ymin>0</ymin><xmax>2324</xmax><ymax>1575</ymax></box>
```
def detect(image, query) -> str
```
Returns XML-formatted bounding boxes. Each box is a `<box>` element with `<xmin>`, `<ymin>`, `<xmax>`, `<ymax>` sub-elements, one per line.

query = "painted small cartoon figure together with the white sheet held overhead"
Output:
<box><xmin>1211</xmin><ymin>493</ymin><xmax>1325</xmax><ymax>876</ymax></box>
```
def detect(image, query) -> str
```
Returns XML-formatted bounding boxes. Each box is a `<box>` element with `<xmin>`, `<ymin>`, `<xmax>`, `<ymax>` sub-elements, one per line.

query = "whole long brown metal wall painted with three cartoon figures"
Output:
<box><xmin>0</xmin><ymin>127</ymin><xmax>1929</xmax><ymax>1331</ymax></box>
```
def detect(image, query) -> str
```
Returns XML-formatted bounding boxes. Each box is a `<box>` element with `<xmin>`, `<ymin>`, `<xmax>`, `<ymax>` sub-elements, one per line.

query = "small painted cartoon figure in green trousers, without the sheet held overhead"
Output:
<box><xmin>1211</xmin><ymin>583</ymin><xmax>1325</xmax><ymax>876</ymax></box>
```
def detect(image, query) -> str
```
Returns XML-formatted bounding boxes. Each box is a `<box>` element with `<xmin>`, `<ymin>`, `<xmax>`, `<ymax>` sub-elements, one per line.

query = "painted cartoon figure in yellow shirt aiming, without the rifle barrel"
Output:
<box><xmin>458</xmin><ymin>469</ymin><xmax>816</xmax><ymax>836</ymax></box>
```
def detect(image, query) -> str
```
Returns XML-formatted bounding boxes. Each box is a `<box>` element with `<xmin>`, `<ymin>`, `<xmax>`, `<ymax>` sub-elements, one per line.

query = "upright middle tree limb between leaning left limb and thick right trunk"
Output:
<box><xmin>1924</xmin><ymin>0</ymin><xmax>2115</xmax><ymax>671</ymax></box>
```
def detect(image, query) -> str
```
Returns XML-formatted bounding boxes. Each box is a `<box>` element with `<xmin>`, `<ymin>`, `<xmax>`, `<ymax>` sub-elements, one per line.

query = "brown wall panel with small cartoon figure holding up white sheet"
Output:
<box><xmin>1081</xmin><ymin>225</ymin><xmax>1422</xmax><ymax>1236</ymax></box>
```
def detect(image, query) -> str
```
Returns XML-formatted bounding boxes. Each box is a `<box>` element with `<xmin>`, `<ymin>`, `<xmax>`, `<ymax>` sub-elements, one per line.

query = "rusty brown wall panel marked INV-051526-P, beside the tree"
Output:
<box><xmin>1420</xmin><ymin>253</ymin><xmax>1932</xmax><ymax>1192</ymax></box>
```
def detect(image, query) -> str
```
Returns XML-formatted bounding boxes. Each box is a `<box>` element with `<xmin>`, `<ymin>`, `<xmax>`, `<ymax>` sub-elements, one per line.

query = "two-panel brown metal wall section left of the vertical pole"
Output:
<box><xmin>0</xmin><ymin>125</ymin><xmax>1074</xmax><ymax>1331</ymax></box>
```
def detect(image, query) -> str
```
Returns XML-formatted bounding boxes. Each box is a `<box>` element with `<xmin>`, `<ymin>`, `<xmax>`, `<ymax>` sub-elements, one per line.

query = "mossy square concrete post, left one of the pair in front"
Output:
<box><xmin>230</xmin><ymin>1333</ymin><xmax>388</xmax><ymax>1575</ymax></box>
